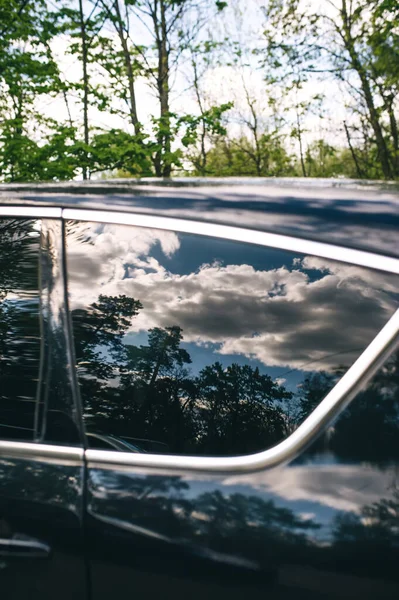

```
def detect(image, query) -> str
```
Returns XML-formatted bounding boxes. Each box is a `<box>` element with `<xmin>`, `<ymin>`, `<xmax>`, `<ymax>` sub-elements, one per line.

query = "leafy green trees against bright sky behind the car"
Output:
<box><xmin>0</xmin><ymin>0</ymin><xmax>399</xmax><ymax>183</ymax></box>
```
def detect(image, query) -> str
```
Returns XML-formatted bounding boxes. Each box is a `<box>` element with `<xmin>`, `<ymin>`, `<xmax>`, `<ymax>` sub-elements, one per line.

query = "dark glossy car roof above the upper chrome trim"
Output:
<box><xmin>0</xmin><ymin>178</ymin><xmax>399</xmax><ymax>257</ymax></box>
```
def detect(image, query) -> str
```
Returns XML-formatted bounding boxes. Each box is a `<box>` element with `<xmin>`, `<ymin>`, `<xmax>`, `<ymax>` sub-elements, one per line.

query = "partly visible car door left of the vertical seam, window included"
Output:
<box><xmin>0</xmin><ymin>214</ymin><xmax>87</xmax><ymax>600</ymax></box>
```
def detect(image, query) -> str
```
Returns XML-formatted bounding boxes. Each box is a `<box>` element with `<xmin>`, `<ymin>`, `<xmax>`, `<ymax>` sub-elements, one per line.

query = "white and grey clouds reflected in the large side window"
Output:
<box><xmin>68</xmin><ymin>224</ymin><xmax>398</xmax><ymax>370</ymax></box>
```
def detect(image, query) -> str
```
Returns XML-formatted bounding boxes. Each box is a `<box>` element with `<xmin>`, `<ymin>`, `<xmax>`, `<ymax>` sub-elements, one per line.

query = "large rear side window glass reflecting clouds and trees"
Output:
<box><xmin>67</xmin><ymin>222</ymin><xmax>399</xmax><ymax>456</ymax></box>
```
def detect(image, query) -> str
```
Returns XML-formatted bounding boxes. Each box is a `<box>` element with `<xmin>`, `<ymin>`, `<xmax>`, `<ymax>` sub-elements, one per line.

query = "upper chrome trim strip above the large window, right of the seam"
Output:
<box><xmin>62</xmin><ymin>208</ymin><xmax>399</xmax><ymax>275</ymax></box>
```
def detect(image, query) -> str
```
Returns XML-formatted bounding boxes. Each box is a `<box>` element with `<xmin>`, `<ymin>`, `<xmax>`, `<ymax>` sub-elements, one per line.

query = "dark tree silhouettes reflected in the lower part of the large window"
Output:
<box><xmin>72</xmin><ymin>296</ymin><xmax>292</xmax><ymax>454</ymax></box>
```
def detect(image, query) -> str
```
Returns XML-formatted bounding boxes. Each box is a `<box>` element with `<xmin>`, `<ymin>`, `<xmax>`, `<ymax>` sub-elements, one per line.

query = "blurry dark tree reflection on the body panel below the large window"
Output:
<box><xmin>90</xmin><ymin>470</ymin><xmax>319</xmax><ymax>568</ymax></box>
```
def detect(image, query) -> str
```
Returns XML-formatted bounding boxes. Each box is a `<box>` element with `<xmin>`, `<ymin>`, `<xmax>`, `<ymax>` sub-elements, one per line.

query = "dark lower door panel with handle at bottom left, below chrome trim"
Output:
<box><xmin>0</xmin><ymin>444</ymin><xmax>87</xmax><ymax>600</ymax></box>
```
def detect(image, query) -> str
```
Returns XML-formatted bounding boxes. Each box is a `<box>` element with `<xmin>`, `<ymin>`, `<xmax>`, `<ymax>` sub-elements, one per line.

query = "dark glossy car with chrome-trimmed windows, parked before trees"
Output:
<box><xmin>0</xmin><ymin>178</ymin><xmax>399</xmax><ymax>600</ymax></box>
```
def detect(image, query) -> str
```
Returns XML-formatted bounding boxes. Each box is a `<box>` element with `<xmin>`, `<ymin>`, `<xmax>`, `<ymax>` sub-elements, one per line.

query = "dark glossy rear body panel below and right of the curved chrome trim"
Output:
<box><xmin>87</xmin><ymin>353</ymin><xmax>399</xmax><ymax>600</ymax></box>
